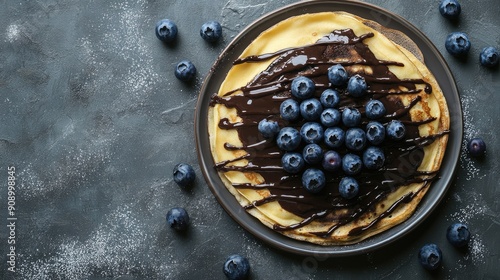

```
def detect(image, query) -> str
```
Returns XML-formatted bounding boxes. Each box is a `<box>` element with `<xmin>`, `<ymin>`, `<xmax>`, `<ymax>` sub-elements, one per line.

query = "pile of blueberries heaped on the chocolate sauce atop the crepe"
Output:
<box><xmin>258</xmin><ymin>64</ymin><xmax>406</xmax><ymax>199</ymax></box>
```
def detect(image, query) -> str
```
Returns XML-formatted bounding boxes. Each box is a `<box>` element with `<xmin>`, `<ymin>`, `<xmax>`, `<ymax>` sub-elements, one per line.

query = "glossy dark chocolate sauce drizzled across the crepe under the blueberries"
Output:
<box><xmin>210</xmin><ymin>29</ymin><xmax>448</xmax><ymax>237</ymax></box>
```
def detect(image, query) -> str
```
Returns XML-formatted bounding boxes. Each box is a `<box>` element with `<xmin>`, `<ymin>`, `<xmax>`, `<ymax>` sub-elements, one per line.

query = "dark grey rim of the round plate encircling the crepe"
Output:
<box><xmin>194</xmin><ymin>0</ymin><xmax>463</xmax><ymax>257</ymax></box>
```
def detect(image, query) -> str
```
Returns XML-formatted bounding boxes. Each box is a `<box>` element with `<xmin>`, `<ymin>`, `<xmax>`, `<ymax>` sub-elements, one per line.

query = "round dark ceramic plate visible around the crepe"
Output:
<box><xmin>195</xmin><ymin>1</ymin><xmax>463</xmax><ymax>256</ymax></box>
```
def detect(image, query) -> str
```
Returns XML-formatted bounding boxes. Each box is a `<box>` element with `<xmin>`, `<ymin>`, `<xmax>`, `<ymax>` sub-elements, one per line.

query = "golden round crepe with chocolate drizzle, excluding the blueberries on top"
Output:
<box><xmin>208</xmin><ymin>12</ymin><xmax>449</xmax><ymax>245</ymax></box>
